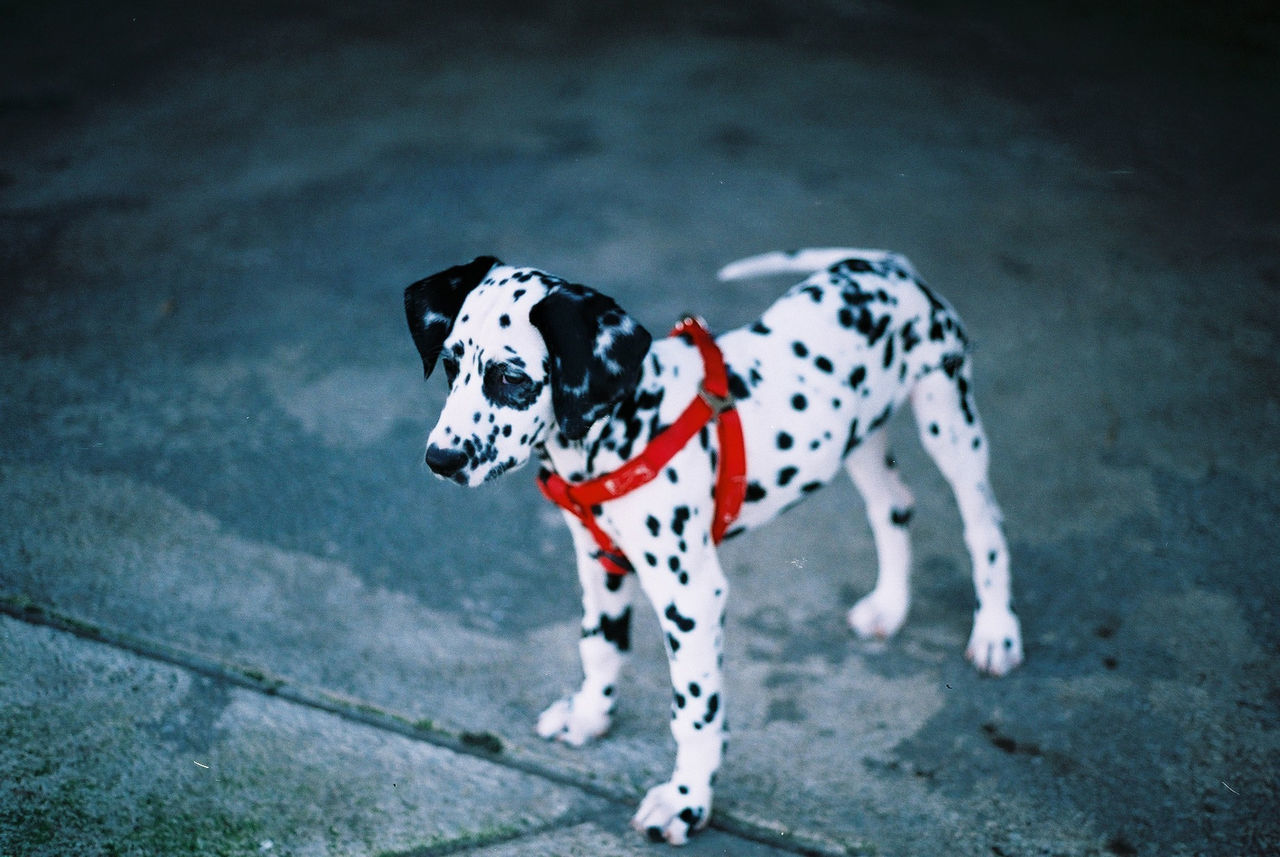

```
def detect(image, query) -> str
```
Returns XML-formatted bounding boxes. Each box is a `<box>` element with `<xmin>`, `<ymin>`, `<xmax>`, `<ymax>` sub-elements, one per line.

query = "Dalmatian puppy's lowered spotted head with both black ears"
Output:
<box><xmin>404</xmin><ymin>256</ymin><xmax>650</xmax><ymax>485</ymax></box>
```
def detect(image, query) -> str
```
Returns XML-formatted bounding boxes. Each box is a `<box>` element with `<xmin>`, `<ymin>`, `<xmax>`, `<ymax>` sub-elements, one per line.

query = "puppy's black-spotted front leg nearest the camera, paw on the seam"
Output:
<box><xmin>631</xmin><ymin>545</ymin><xmax>728</xmax><ymax>845</ymax></box>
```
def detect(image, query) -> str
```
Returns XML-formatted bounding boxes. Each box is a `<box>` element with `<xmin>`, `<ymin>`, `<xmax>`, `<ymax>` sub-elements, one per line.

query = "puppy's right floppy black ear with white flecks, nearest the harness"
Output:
<box><xmin>529</xmin><ymin>283</ymin><xmax>652</xmax><ymax>440</ymax></box>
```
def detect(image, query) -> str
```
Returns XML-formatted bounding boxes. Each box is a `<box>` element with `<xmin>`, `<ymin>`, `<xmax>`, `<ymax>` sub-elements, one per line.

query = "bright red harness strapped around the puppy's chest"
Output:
<box><xmin>538</xmin><ymin>316</ymin><xmax>746</xmax><ymax>574</ymax></box>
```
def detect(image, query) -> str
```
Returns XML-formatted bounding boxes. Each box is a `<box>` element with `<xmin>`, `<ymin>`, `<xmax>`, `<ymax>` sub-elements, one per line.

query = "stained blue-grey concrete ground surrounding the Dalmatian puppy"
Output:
<box><xmin>0</xmin><ymin>0</ymin><xmax>1280</xmax><ymax>856</ymax></box>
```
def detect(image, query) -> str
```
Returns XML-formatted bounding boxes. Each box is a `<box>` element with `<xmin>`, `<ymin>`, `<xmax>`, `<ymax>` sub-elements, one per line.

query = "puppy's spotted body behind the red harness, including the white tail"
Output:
<box><xmin>718</xmin><ymin>248</ymin><xmax>965</xmax><ymax>530</ymax></box>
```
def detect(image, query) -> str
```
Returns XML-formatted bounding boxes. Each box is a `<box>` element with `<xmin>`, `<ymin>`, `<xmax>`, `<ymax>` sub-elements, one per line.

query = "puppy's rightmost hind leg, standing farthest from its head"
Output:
<box><xmin>911</xmin><ymin>361</ymin><xmax>1023</xmax><ymax>675</ymax></box>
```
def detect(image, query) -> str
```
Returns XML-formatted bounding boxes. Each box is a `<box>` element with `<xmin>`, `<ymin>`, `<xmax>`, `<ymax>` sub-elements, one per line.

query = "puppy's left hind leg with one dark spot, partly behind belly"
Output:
<box><xmin>845</xmin><ymin>430</ymin><xmax>915</xmax><ymax>640</ymax></box>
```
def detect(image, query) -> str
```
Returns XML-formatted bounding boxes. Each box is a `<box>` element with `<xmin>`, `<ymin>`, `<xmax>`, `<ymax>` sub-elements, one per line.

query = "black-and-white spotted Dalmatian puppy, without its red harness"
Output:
<box><xmin>404</xmin><ymin>249</ymin><xmax>1023</xmax><ymax>844</ymax></box>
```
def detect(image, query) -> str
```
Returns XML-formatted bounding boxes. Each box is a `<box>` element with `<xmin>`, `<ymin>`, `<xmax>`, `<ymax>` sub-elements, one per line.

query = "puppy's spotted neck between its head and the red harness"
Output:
<box><xmin>539</xmin><ymin>338</ymin><xmax>703</xmax><ymax>482</ymax></box>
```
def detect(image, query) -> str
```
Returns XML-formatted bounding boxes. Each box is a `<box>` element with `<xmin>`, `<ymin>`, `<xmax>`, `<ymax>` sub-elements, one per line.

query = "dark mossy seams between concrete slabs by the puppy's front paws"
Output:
<box><xmin>0</xmin><ymin>591</ymin><xmax>864</xmax><ymax>857</ymax></box>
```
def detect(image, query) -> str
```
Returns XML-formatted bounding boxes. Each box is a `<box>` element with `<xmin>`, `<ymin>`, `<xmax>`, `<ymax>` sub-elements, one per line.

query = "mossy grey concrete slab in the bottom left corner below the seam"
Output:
<box><xmin>0</xmin><ymin>617</ymin><xmax>604</xmax><ymax>856</ymax></box>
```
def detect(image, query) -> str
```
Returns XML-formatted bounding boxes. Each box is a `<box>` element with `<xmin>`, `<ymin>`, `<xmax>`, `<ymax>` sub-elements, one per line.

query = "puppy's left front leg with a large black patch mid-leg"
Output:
<box><xmin>538</xmin><ymin>514</ymin><xmax>635</xmax><ymax>747</ymax></box>
